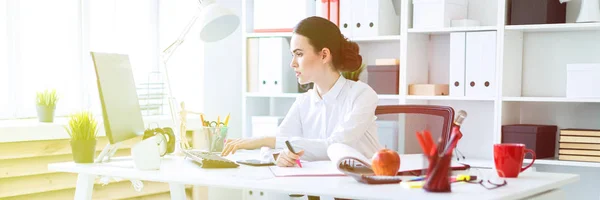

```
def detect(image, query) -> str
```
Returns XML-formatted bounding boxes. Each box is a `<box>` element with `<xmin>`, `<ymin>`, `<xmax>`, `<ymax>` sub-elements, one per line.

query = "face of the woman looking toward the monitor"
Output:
<box><xmin>290</xmin><ymin>34</ymin><xmax>326</xmax><ymax>84</ymax></box>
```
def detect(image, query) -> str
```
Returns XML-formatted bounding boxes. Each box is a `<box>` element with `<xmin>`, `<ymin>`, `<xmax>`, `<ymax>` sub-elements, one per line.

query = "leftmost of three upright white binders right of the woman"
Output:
<box><xmin>448</xmin><ymin>32</ymin><xmax>466</xmax><ymax>96</ymax></box>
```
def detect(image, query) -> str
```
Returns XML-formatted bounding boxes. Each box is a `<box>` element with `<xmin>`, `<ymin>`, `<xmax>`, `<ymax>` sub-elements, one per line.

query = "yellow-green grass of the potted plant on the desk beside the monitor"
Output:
<box><xmin>65</xmin><ymin>111</ymin><xmax>98</xmax><ymax>140</ymax></box>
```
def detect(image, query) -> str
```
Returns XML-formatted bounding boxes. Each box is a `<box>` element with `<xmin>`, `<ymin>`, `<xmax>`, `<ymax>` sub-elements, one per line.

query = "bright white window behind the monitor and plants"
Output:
<box><xmin>0</xmin><ymin>0</ymin><xmax>168</xmax><ymax>119</ymax></box>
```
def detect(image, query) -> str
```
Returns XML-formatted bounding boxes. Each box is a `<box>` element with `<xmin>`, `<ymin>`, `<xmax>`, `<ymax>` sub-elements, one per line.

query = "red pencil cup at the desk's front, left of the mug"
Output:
<box><xmin>423</xmin><ymin>154</ymin><xmax>452</xmax><ymax>192</ymax></box>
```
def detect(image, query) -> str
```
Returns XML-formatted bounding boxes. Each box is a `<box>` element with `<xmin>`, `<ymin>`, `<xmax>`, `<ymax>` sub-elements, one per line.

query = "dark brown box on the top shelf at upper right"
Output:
<box><xmin>507</xmin><ymin>0</ymin><xmax>567</xmax><ymax>25</ymax></box>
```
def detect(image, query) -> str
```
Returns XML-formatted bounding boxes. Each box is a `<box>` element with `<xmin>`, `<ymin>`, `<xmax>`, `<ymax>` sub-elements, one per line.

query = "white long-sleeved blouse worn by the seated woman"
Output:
<box><xmin>275</xmin><ymin>76</ymin><xmax>382</xmax><ymax>161</ymax></box>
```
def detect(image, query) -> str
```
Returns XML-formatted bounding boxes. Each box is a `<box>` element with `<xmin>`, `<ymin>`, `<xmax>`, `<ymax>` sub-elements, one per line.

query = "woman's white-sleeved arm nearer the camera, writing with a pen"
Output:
<box><xmin>276</xmin><ymin>87</ymin><xmax>379</xmax><ymax>160</ymax></box>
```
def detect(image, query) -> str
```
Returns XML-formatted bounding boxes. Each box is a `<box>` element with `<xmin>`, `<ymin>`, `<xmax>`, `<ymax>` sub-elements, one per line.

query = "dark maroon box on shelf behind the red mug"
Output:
<box><xmin>502</xmin><ymin>124</ymin><xmax>558</xmax><ymax>159</ymax></box>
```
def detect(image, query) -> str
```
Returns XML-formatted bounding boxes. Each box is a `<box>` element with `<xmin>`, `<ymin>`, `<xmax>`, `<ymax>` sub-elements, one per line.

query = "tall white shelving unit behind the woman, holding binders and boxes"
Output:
<box><xmin>242</xmin><ymin>0</ymin><xmax>600</xmax><ymax>198</ymax></box>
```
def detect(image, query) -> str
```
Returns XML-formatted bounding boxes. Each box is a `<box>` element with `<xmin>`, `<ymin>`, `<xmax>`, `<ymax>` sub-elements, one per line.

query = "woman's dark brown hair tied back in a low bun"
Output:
<box><xmin>294</xmin><ymin>16</ymin><xmax>362</xmax><ymax>72</ymax></box>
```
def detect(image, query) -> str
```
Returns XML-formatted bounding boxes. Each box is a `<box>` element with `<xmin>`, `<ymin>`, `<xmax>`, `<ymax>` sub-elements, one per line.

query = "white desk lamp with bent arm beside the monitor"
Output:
<box><xmin>161</xmin><ymin>0</ymin><xmax>240</xmax><ymax>154</ymax></box>
